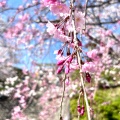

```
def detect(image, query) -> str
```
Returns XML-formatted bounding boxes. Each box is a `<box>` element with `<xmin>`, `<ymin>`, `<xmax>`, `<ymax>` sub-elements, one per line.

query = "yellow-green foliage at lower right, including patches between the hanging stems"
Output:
<box><xmin>70</xmin><ymin>88</ymin><xmax>120</xmax><ymax>120</ymax></box>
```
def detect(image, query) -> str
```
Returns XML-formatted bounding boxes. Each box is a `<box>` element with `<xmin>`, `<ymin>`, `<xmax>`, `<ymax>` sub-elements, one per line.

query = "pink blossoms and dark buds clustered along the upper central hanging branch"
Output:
<box><xmin>46</xmin><ymin>1</ymin><xmax>99</xmax><ymax>85</ymax></box>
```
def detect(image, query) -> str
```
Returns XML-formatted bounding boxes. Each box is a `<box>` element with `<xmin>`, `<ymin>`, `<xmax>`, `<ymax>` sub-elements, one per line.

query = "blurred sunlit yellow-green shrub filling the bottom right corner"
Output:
<box><xmin>94</xmin><ymin>88</ymin><xmax>120</xmax><ymax>120</ymax></box>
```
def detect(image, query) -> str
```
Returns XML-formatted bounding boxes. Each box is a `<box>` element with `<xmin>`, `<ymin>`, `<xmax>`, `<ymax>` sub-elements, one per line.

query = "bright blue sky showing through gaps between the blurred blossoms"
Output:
<box><xmin>3</xmin><ymin>0</ymin><xmax>120</xmax><ymax>70</ymax></box>
